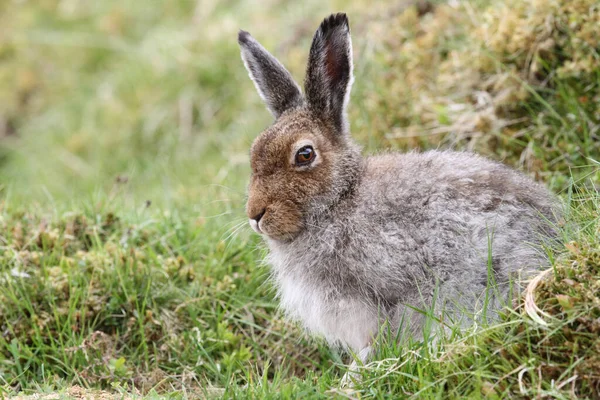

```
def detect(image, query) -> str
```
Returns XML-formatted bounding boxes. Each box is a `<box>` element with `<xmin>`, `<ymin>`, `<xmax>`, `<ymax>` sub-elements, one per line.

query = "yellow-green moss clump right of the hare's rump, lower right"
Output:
<box><xmin>534</xmin><ymin>242</ymin><xmax>600</xmax><ymax>397</ymax></box>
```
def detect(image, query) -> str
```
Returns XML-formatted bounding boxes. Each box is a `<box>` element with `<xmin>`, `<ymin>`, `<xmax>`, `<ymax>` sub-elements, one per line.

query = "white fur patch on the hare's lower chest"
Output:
<box><xmin>269</xmin><ymin>248</ymin><xmax>378</xmax><ymax>352</ymax></box>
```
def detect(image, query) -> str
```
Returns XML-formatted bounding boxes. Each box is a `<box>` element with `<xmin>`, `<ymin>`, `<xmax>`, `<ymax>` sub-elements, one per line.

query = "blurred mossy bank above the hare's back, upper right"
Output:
<box><xmin>354</xmin><ymin>0</ymin><xmax>600</xmax><ymax>180</ymax></box>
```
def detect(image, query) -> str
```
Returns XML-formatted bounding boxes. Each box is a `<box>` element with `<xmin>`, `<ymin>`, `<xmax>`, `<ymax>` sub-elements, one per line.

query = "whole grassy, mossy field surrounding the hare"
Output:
<box><xmin>0</xmin><ymin>0</ymin><xmax>600</xmax><ymax>399</ymax></box>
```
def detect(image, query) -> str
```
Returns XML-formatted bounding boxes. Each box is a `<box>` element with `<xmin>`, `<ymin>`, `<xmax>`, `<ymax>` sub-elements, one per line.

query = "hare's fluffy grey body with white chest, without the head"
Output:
<box><xmin>268</xmin><ymin>151</ymin><xmax>555</xmax><ymax>351</ymax></box>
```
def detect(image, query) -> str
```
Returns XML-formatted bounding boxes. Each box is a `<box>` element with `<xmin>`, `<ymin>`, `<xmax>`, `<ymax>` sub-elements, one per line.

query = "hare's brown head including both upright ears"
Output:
<box><xmin>238</xmin><ymin>14</ymin><xmax>361</xmax><ymax>241</ymax></box>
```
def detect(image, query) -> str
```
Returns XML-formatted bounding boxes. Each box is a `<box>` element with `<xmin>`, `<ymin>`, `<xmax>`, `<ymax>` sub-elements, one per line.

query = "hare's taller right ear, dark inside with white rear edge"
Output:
<box><xmin>304</xmin><ymin>13</ymin><xmax>353</xmax><ymax>134</ymax></box>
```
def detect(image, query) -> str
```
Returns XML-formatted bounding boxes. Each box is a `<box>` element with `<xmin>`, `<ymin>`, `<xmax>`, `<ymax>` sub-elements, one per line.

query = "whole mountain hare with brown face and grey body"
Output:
<box><xmin>238</xmin><ymin>13</ymin><xmax>557</xmax><ymax>366</ymax></box>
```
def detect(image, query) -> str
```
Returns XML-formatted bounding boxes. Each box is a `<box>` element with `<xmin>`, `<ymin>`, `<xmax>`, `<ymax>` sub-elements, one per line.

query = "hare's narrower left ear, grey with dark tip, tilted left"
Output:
<box><xmin>238</xmin><ymin>31</ymin><xmax>303</xmax><ymax>118</ymax></box>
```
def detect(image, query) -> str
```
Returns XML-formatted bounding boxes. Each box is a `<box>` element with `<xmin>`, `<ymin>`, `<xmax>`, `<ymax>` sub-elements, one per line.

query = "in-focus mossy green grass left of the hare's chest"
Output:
<box><xmin>0</xmin><ymin>198</ymin><xmax>327</xmax><ymax>391</ymax></box>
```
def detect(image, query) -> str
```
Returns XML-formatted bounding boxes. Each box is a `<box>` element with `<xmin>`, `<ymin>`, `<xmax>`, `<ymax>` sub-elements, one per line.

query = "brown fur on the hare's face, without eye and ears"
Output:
<box><xmin>246</xmin><ymin>109</ymin><xmax>346</xmax><ymax>241</ymax></box>
